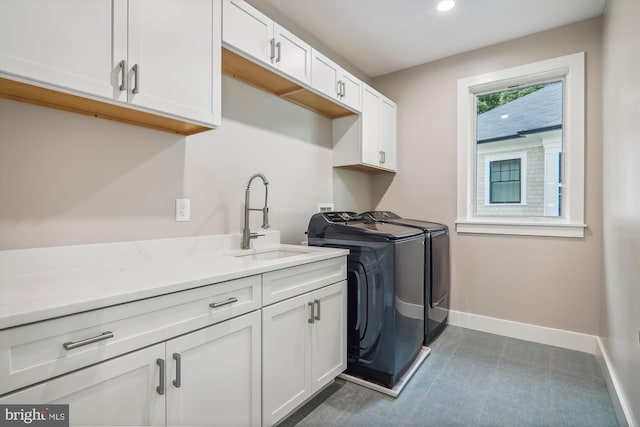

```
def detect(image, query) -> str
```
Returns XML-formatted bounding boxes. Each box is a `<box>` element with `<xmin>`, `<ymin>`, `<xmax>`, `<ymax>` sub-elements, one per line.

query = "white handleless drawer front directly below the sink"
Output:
<box><xmin>262</xmin><ymin>256</ymin><xmax>347</xmax><ymax>306</ymax></box>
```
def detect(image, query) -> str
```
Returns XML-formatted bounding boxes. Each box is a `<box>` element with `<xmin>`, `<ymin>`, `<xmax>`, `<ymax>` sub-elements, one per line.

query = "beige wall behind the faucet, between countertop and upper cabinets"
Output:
<box><xmin>0</xmin><ymin>77</ymin><xmax>370</xmax><ymax>249</ymax></box>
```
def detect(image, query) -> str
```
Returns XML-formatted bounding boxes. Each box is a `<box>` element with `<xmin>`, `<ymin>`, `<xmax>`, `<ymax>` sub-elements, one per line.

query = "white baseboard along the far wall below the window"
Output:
<box><xmin>449</xmin><ymin>310</ymin><xmax>599</xmax><ymax>355</ymax></box>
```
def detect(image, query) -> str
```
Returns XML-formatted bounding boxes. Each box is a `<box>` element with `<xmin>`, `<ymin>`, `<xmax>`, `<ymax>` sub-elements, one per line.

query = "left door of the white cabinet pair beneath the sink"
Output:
<box><xmin>262</xmin><ymin>293</ymin><xmax>312</xmax><ymax>426</ymax></box>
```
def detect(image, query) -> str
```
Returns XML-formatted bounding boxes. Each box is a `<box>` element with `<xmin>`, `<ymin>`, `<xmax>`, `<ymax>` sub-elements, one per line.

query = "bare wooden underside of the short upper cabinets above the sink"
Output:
<box><xmin>222</xmin><ymin>48</ymin><xmax>356</xmax><ymax>119</ymax></box>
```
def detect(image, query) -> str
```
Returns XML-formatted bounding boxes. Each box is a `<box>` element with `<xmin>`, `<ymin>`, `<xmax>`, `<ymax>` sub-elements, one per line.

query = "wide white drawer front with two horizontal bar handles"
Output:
<box><xmin>0</xmin><ymin>276</ymin><xmax>261</xmax><ymax>394</ymax></box>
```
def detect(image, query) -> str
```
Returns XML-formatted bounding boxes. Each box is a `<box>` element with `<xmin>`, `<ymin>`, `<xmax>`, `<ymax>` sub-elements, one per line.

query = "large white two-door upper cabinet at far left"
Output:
<box><xmin>0</xmin><ymin>0</ymin><xmax>222</xmax><ymax>128</ymax></box>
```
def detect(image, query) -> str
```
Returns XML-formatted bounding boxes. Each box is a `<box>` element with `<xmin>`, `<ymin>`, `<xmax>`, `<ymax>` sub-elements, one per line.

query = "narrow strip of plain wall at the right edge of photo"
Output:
<box><xmin>602</xmin><ymin>0</ymin><xmax>640</xmax><ymax>425</ymax></box>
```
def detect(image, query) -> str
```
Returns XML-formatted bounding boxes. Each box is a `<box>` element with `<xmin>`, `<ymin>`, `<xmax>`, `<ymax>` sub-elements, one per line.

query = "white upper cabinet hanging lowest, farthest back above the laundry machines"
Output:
<box><xmin>333</xmin><ymin>85</ymin><xmax>397</xmax><ymax>172</ymax></box>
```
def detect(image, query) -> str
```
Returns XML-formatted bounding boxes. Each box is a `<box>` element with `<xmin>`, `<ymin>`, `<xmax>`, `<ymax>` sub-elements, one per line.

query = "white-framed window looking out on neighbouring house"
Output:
<box><xmin>456</xmin><ymin>53</ymin><xmax>585</xmax><ymax>237</ymax></box>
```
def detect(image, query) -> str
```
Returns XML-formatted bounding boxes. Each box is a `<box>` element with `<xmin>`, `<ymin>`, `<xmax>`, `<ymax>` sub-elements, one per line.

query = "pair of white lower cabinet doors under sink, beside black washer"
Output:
<box><xmin>262</xmin><ymin>281</ymin><xmax>347</xmax><ymax>426</ymax></box>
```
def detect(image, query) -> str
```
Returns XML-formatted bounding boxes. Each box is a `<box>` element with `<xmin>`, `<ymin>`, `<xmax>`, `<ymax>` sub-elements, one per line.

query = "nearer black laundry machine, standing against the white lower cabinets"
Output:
<box><xmin>307</xmin><ymin>212</ymin><xmax>425</xmax><ymax>388</ymax></box>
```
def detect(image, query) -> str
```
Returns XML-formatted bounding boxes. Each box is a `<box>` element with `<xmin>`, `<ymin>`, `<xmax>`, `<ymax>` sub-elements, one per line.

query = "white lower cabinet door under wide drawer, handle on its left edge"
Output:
<box><xmin>166</xmin><ymin>311</ymin><xmax>261</xmax><ymax>427</ymax></box>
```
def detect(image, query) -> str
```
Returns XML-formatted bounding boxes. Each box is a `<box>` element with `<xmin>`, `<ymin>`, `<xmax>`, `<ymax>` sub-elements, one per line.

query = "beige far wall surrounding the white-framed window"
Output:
<box><xmin>372</xmin><ymin>18</ymin><xmax>603</xmax><ymax>335</ymax></box>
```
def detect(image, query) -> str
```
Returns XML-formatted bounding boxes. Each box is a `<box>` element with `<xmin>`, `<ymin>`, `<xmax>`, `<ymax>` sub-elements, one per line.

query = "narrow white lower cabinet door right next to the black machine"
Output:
<box><xmin>311</xmin><ymin>281</ymin><xmax>347</xmax><ymax>393</ymax></box>
